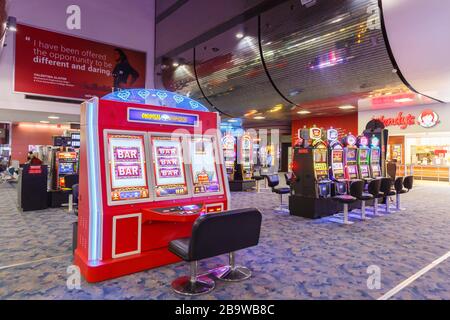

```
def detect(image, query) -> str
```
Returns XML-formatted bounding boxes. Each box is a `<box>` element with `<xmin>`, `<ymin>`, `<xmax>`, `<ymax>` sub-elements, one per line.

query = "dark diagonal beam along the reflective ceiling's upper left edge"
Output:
<box><xmin>155</xmin><ymin>0</ymin><xmax>291</xmax><ymax>64</ymax></box>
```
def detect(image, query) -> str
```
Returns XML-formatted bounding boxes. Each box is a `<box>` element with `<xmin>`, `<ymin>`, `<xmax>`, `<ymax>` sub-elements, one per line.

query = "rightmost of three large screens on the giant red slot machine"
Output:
<box><xmin>190</xmin><ymin>137</ymin><xmax>221</xmax><ymax>195</ymax></box>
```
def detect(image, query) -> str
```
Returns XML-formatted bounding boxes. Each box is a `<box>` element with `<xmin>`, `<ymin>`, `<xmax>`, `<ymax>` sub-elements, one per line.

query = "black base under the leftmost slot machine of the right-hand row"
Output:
<box><xmin>289</xmin><ymin>195</ymin><xmax>338</xmax><ymax>219</ymax></box>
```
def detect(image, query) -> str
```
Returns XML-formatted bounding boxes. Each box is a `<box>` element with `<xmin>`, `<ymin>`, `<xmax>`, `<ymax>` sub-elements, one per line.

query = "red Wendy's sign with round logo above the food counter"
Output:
<box><xmin>373</xmin><ymin>109</ymin><xmax>439</xmax><ymax>130</ymax></box>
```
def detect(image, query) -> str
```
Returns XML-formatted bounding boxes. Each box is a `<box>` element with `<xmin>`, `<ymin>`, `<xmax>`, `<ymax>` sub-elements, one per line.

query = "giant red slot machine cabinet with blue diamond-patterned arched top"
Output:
<box><xmin>74</xmin><ymin>89</ymin><xmax>230</xmax><ymax>282</ymax></box>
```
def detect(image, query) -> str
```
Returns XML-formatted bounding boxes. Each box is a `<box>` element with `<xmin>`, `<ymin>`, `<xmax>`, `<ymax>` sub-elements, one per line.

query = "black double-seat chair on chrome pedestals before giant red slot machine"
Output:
<box><xmin>169</xmin><ymin>209</ymin><xmax>262</xmax><ymax>295</ymax></box>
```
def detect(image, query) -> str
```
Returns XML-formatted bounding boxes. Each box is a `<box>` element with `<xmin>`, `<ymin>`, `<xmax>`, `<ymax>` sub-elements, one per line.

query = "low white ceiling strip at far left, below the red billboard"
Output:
<box><xmin>0</xmin><ymin>109</ymin><xmax>80</xmax><ymax>124</ymax></box>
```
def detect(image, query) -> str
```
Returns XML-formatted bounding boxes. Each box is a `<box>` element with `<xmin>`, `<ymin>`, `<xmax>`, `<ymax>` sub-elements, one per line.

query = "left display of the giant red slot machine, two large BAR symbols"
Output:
<box><xmin>107</xmin><ymin>134</ymin><xmax>149</xmax><ymax>202</ymax></box>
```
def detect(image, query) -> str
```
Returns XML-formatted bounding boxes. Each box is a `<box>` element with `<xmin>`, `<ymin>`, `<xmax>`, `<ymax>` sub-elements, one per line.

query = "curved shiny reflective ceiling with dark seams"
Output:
<box><xmin>156</xmin><ymin>0</ymin><xmax>435</xmax><ymax>123</ymax></box>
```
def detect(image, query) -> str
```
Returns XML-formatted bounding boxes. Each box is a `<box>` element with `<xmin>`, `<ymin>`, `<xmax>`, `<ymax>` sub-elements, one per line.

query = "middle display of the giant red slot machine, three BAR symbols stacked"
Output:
<box><xmin>151</xmin><ymin>136</ymin><xmax>188</xmax><ymax>198</ymax></box>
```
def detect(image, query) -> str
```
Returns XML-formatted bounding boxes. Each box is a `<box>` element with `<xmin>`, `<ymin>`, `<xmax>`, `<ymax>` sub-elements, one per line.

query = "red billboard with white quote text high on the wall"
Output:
<box><xmin>14</xmin><ymin>25</ymin><xmax>146</xmax><ymax>99</ymax></box>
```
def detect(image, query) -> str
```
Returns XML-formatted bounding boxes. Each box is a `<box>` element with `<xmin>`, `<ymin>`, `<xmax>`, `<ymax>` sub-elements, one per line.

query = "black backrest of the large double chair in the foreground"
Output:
<box><xmin>189</xmin><ymin>209</ymin><xmax>262</xmax><ymax>261</ymax></box>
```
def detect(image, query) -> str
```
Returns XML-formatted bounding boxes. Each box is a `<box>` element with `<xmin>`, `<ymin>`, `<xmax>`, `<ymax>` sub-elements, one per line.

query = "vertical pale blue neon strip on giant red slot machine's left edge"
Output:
<box><xmin>86</xmin><ymin>100</ymin><xmax>102</xmax><ymax>264</ymax></box>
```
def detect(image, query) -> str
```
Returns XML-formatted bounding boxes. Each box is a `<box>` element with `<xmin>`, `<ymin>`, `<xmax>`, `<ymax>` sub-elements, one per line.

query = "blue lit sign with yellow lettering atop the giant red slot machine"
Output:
<box><xmin>128</xmin><ymin>108</ymin><xmax>198</xmax><ymax>127</ymax></box>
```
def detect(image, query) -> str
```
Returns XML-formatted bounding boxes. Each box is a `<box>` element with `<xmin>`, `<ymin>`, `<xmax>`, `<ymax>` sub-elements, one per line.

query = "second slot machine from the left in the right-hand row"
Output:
<box><xmin>327</xmin><ymin>128</ymin><xmax>347</xmax><ymax>195</ymax></box>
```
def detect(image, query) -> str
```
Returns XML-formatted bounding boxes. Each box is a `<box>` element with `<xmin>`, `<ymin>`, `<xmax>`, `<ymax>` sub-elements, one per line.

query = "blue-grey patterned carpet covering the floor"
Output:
<box><xmin>0</xmin><ymin>184</ymin><xmax>450</xmax><ymax>299</ymax></box>
